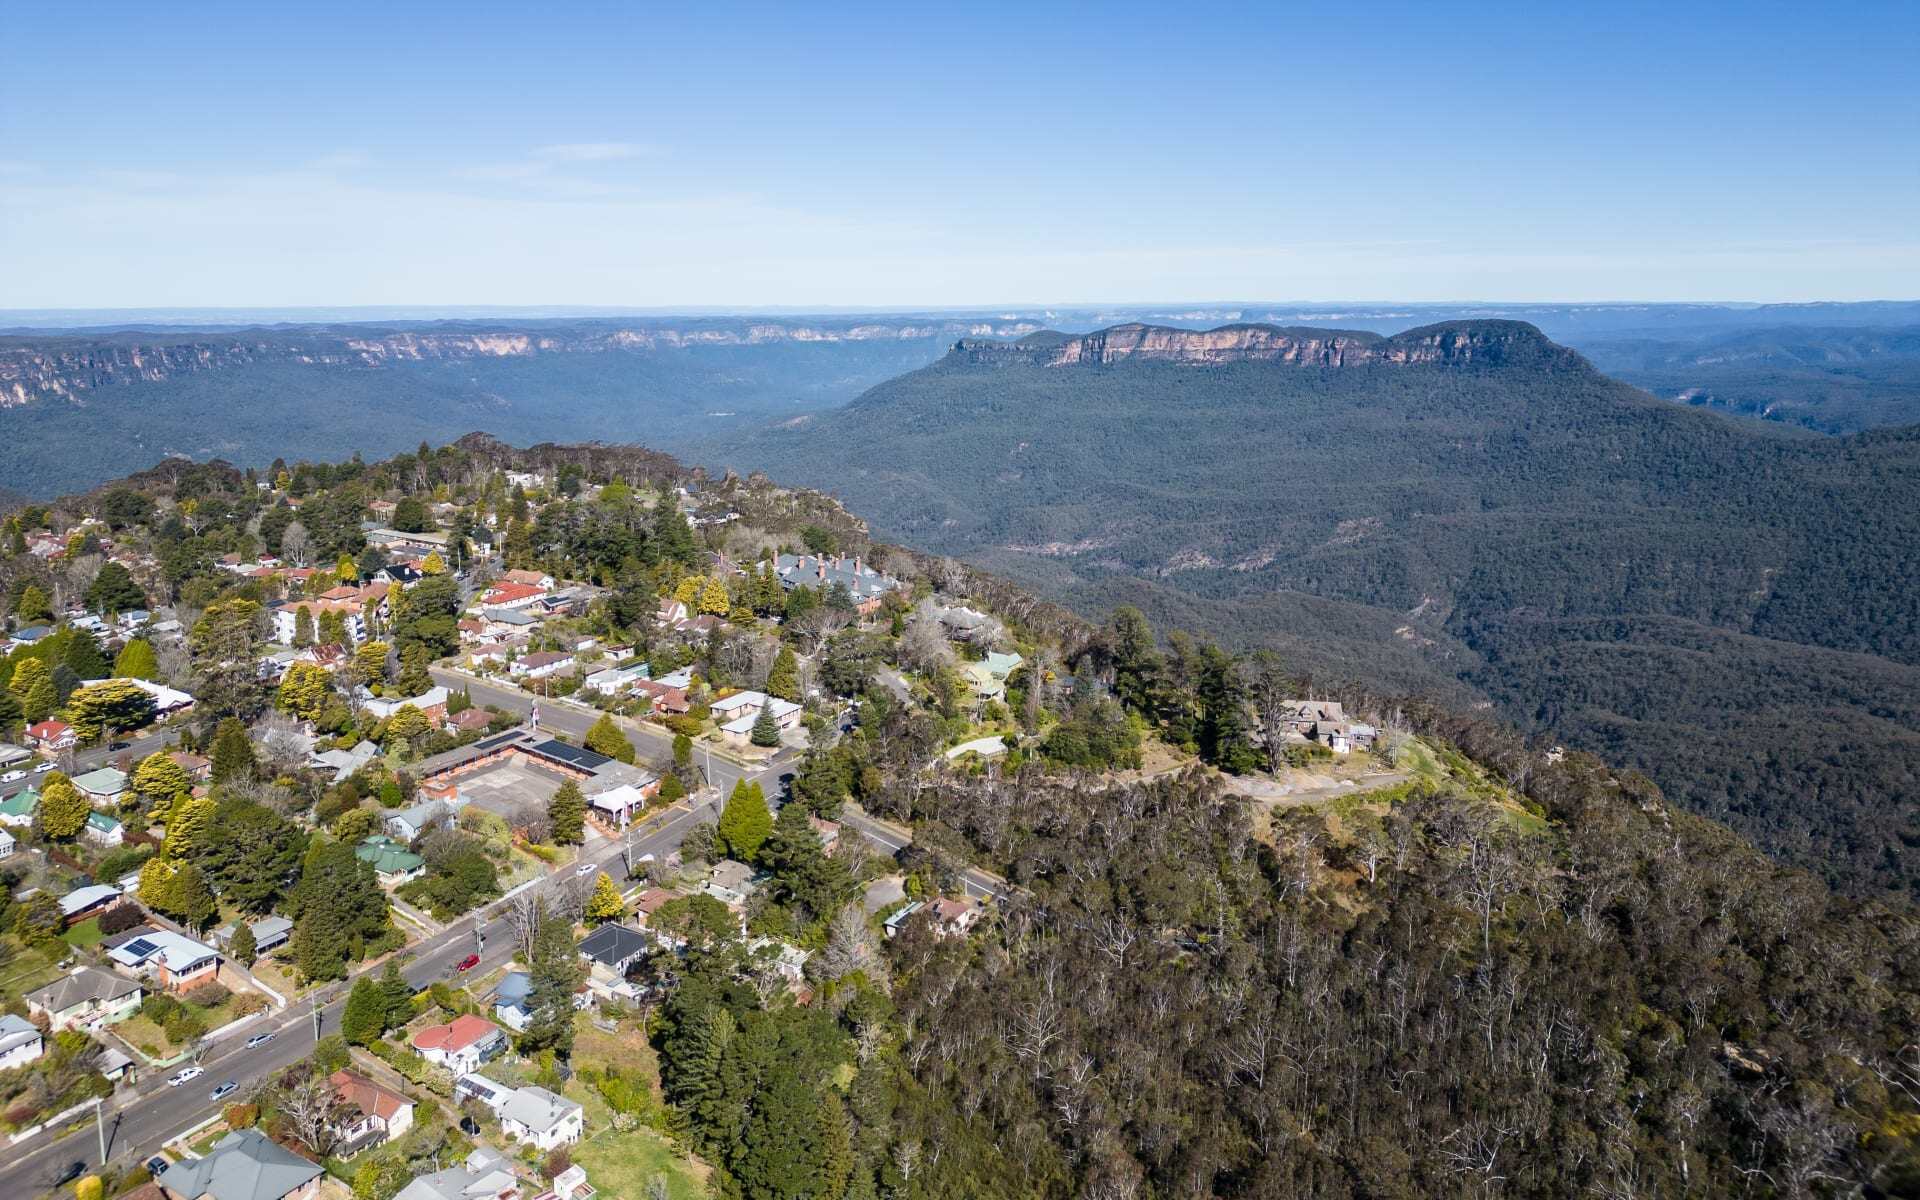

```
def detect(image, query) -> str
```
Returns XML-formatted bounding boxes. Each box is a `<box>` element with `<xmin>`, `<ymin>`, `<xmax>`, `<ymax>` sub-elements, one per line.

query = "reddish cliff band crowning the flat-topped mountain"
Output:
<box><xmin>948</xmin><ymin>321</ymin><xmax>1580</xmax><ymax>367</ymax></box>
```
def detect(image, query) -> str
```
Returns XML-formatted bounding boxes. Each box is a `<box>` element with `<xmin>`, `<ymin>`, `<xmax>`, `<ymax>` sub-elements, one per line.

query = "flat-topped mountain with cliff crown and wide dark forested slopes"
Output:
<box><xmin>705</xmin><ymin>321</ymin><xmax>1920</xmax><ymax>891</ymax></box>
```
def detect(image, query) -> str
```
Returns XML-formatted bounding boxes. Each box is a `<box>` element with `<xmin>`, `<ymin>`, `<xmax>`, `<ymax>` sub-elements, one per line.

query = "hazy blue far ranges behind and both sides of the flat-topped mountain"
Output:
<box><xmin>11</xmin><ymin>301</ymin><xmax>1920</xmax><ymax>497</ymax></box>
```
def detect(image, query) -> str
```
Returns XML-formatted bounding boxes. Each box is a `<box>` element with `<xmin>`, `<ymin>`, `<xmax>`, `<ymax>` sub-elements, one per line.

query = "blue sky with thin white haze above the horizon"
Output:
<box><xmin>0</xmin><ymin>0</ymin><xmax>1920</xmax><ymax>307</ymax></box>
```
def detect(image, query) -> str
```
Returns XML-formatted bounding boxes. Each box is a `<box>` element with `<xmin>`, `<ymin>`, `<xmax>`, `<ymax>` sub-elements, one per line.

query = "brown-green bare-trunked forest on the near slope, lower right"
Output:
<box><xmin>879</xmin><ymin>726</ymin><xmax>1920</xmax><ymax>1198</ymax></box>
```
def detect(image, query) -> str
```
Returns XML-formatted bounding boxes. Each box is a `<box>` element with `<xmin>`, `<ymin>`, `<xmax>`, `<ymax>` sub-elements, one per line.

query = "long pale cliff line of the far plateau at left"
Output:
<box><xmin>0</xmin><ymin>319</ymin><xmax>1039</xmax><ymax>407</ymax></box>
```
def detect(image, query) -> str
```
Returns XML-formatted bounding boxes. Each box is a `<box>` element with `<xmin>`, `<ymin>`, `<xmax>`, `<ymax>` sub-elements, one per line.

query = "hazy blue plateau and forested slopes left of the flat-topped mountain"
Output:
<box><xmin>0</xmin><ymin>317</ymin><xmax>1035</xmax><ymax>495</ymax></box>
